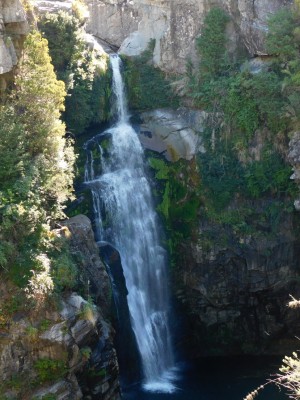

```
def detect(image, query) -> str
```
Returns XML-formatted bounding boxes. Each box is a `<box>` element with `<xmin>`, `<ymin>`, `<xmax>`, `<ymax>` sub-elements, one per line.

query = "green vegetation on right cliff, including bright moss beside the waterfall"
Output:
<box><xmin>147</xmin><ymin>8</ymin><xmax>300</xmax><ymax>264</ymax></box>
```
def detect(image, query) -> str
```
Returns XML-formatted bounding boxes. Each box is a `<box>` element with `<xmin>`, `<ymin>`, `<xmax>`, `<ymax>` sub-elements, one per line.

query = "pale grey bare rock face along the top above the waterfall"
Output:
<box><xmin>85</xmin><ymin>0</ymin><xmax>293</xmax><ymax>73</ymax></box>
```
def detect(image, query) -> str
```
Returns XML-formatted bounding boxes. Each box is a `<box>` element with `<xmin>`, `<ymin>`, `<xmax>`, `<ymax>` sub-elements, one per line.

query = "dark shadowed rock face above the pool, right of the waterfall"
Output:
<box><xmin>174</xmin><ymin>211</ymin><xmax>300</xmax><ymax>356</ymax></box>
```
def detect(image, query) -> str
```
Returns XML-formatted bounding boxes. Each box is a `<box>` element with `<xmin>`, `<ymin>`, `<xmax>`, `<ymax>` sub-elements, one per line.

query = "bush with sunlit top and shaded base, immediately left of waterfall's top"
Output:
<box><xmin>39</xmin><ymin>11</ymin><xmax>111</xmax><ymax>134</ymax></box>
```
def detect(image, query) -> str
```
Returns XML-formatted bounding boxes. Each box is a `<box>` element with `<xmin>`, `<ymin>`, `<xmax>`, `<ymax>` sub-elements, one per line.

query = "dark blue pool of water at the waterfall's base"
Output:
<box><xmin>122</xmin><ymin>357</ymin><xmax>288</xmax><ymax>400</ymax></box>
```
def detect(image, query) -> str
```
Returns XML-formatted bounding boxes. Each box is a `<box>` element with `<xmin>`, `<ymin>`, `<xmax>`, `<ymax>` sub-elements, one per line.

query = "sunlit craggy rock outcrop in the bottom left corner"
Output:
<box><xmin>0</xmin><ymin>288</ymin><xmax>118</xmax><ymax>400</ymax></box>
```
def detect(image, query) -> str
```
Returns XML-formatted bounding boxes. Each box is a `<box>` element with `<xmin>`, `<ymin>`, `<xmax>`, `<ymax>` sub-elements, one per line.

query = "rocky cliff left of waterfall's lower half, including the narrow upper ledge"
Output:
<box><xmin>0</xmin><ymin>216</ymin><xmax>120</xmax><ymax>400</ymax></box>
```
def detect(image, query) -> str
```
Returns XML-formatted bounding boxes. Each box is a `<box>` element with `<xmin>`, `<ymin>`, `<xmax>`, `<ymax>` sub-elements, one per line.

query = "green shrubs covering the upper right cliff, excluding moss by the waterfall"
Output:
<box><xmin>188</xmin><ymin>9</ymin><xmax>297</xmax><ymax>238</ymax></box>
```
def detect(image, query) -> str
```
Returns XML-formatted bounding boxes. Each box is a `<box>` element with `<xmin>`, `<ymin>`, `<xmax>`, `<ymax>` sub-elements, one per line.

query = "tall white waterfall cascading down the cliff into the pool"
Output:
<box><xmin>85</xmin><ymin>55</ymin><xmax>175</xmax><ymax>392</ymax></box>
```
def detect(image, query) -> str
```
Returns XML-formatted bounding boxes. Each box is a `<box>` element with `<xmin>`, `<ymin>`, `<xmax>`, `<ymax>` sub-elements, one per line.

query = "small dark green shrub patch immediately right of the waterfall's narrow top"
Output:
<box><xmin>123</xmin><ymin>40</ymin><xmax>179</xmax><ymax>111</ymax></box>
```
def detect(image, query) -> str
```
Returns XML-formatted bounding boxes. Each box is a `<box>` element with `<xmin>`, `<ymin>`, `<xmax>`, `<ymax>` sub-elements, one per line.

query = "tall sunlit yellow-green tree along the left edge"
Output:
<box><xmin>0</xmin><ymin>31</ymin><xmax>74</xmax><ymax>291</ymax></box>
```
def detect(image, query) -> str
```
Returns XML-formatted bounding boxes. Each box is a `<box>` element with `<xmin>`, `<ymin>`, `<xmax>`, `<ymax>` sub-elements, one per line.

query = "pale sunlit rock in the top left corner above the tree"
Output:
<box><xmin>0</xmin><ymin>0</ymin><xmax>29</xmax><ymax>91</ymax></box>
